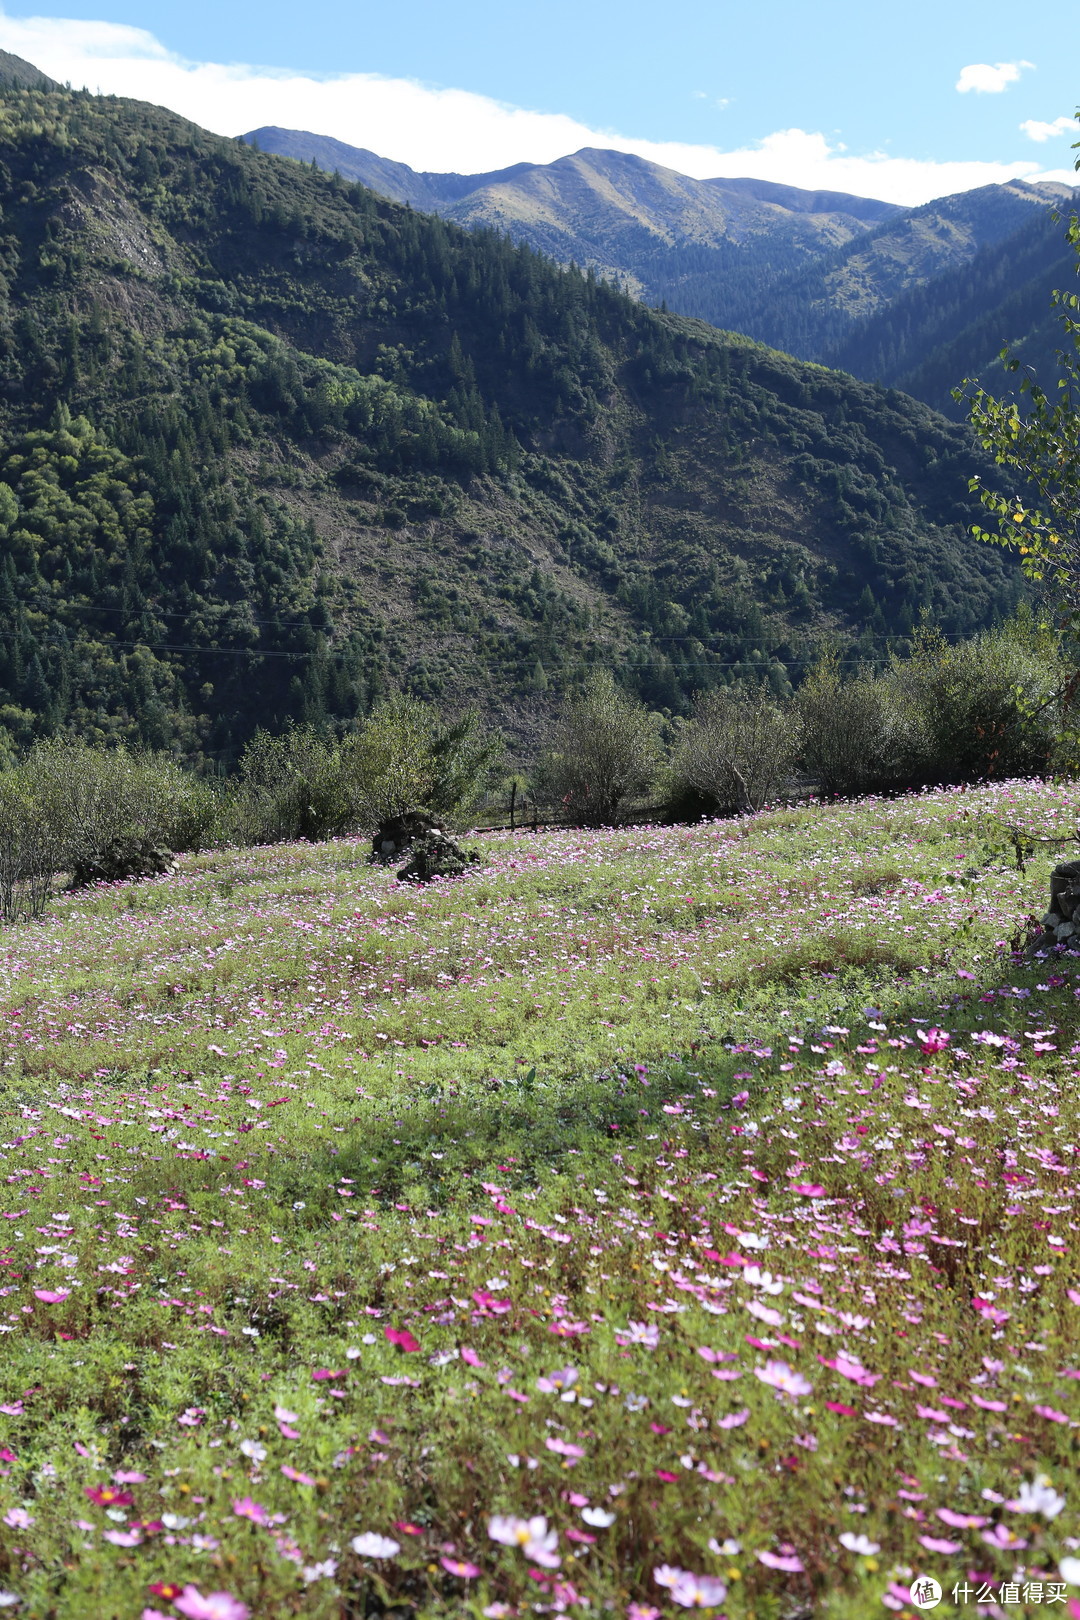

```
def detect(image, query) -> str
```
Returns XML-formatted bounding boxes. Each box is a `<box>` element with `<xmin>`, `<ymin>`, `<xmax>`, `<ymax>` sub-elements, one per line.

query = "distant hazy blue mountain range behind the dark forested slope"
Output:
<box><xmin>244</xmin><ymin>128</ymin><xmax>1080</xmax><ymax>415</ymax></box>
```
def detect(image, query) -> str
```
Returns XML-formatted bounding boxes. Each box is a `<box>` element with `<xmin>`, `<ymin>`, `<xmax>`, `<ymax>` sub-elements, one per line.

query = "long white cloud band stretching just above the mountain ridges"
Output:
<box><xmin>0</xmin><ymin>13</ymin><xmax>1075</xmax><ymax>204</ymax></box>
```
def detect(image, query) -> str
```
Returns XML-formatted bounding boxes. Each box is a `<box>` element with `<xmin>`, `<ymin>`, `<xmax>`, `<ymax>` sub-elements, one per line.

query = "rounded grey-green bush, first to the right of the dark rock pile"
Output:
<box><xmin>538</xmin><ymin>672</ymin><xmax>661</xmax><ymax>826</ymax></box>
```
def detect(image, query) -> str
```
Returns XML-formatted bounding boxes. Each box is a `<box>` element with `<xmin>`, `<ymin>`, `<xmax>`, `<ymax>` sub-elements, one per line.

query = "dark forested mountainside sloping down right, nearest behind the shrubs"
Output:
<box><xmin>0</xmin><ymin>74</ymin><xmax>1020</xmax><ymax>761</ymax></box>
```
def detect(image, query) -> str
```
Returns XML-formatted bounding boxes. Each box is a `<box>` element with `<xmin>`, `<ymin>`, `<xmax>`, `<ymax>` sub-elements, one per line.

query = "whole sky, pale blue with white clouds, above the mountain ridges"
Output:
<box><xmin>0</xmin><ymin>0</ymin><xmax>1080</xmax><ymax>201</ymax></box>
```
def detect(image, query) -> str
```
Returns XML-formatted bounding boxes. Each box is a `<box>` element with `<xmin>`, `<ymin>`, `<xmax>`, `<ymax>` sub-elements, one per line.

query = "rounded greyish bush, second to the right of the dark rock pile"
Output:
<box><xmin>674</xmin><ymin>687</ymin><xmax>798</xmax><ymax>815</ymax></box>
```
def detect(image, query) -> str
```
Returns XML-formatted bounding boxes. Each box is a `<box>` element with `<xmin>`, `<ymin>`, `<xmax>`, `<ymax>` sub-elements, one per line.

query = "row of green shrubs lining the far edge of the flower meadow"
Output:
<box><xmin>0</xmin><ymin>616</ymin><xmax>1075</xmax><ymax>920</ymax></box>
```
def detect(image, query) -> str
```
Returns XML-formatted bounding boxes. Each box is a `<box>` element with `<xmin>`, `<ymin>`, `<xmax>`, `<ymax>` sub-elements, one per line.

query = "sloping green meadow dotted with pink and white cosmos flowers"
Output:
<box><xmin>0</xmin><ymin>782</ymin><xmax>1080</xmax><ymax>1620</ymax></box>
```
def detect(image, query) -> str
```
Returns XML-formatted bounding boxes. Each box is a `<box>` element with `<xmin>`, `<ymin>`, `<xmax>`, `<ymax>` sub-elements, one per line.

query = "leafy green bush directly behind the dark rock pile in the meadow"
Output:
<box><xmin>342</xmin><ymin>697</ymin><xmax>502</xmax><ymax>831</ymax></box>
